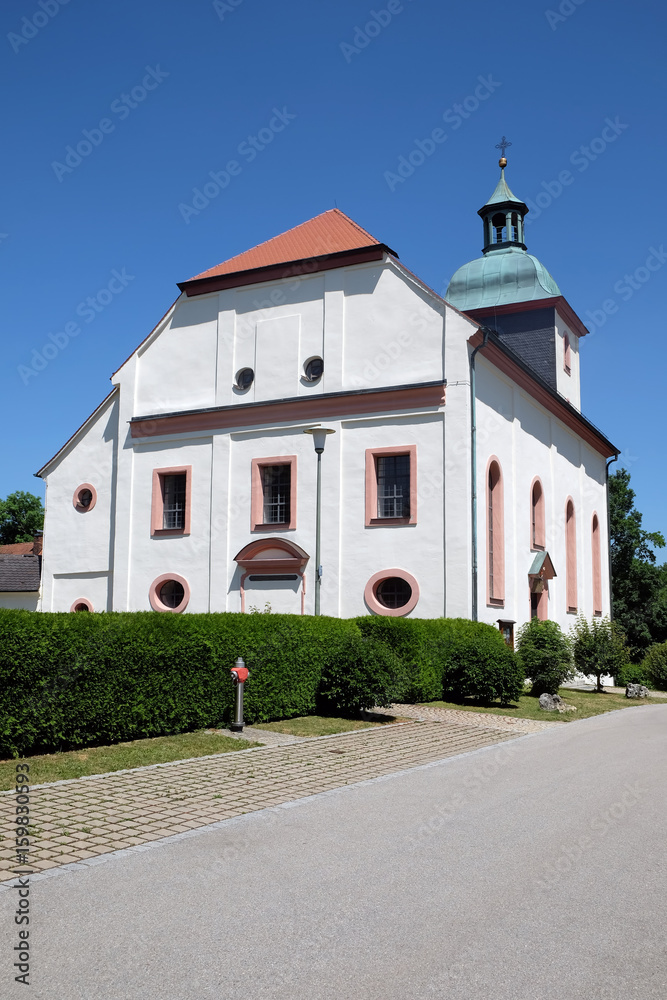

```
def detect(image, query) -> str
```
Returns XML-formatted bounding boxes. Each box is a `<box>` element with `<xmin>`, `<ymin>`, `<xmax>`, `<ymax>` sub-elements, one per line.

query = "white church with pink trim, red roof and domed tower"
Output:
<box><xmin>37</xmin><ymin>156</ymin><xmax>617</xmax><ymax>643</ymax></box>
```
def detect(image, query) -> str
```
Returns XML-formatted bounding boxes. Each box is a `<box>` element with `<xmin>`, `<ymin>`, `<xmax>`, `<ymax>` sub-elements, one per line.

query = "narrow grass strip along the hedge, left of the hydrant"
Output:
<box><xmin>0</xmin><ymin>730</ymin><xmax>258</xmax><ymax>791</ymax></box>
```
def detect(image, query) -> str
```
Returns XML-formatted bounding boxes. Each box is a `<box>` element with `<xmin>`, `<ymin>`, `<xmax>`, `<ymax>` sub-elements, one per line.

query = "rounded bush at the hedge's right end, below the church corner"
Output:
<box><xmin>440</xmin><ymin>618</ymin><xmax>525</xmax><ymax>705</ymax></box>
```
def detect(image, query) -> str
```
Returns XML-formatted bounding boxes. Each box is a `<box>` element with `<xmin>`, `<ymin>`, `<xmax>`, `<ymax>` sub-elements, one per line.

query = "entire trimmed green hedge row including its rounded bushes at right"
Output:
<box><xmin>0</xmin><ymin>609</ymin><xmax>523</xmax><ymax>757</ymax></box>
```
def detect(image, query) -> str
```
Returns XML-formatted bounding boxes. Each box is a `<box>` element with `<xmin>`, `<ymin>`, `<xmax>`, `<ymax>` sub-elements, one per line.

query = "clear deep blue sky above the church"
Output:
<box><xmin>0</xmin><ymin>0</ymin><xmax>667</xmax><ymax>548</ymax></box>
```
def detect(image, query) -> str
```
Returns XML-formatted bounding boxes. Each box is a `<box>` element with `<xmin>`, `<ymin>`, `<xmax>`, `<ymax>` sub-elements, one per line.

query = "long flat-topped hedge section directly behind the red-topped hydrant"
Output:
<box><xmin>0</xmin><ymin>610</ymin><xmax>358</xmax><ymax>756</ymax></box>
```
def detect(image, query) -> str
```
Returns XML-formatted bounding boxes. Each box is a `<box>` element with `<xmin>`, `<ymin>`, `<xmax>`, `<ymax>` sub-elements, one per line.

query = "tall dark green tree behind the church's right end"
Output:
<box><xmin>609</xmin><ymin>469</ymin><xmax>667</xmax><ymax>662</ymax></box>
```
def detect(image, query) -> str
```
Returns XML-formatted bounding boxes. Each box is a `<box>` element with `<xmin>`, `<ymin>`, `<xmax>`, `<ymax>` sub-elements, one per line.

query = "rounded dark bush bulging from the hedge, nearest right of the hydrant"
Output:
<box><xmin>318</xmin><ymin>634</ymin><xmax>401</xmax><ymax>714</ymax></box>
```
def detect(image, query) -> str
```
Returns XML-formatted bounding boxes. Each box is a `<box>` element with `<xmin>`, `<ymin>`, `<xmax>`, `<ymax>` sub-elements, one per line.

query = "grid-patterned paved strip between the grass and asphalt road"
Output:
<box><xmin>0</xmin><ymin>712</ymin><xmax>522</xmax><ymax>881</ymax></box>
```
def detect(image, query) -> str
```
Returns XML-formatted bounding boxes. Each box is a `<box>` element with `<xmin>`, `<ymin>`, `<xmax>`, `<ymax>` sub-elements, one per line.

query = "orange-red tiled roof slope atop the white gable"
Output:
<box><xmin>185</xmin><ymin>208</ymin><xmax>384</xmax><ymax>281</ymax></box>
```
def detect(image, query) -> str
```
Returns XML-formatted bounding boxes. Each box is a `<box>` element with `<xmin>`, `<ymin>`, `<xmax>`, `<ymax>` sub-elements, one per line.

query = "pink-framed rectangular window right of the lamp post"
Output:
<box><xmin>365</xmin><ymin>444</ymin><xmax>417</xmax><ymax>528</ymax></box>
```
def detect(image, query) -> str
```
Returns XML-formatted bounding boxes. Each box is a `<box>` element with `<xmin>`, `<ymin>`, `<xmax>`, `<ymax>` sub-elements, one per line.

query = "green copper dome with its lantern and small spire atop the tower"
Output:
<box><xmin>445</xmin><ymin>157</ymin><xmax>561</xmax><ymax>312</ymax></box>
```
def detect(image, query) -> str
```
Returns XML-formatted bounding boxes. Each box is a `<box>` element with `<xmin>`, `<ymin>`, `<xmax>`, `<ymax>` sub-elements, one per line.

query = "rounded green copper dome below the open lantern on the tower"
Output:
<box><xmin>445</xmin><ymin>247</ymin><xmax>561</xmax><ymax>312</ymax></box>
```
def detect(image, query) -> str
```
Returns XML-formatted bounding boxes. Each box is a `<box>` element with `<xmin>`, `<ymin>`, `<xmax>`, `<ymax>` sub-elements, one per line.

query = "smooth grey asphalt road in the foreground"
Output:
<box><xmin>0</xmin><ymin>705</ymin><xmax>667</xmax><ymax>1000</ymax></box>
